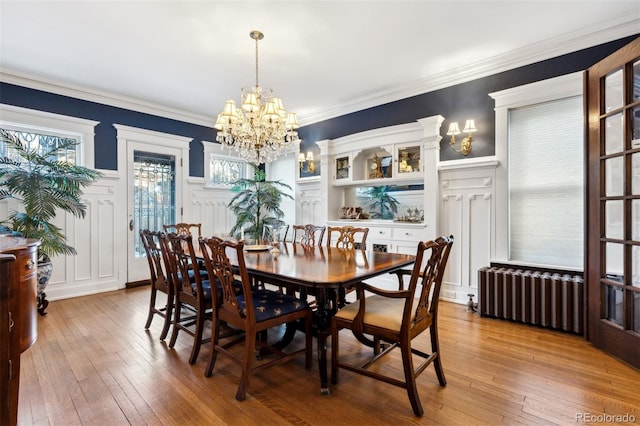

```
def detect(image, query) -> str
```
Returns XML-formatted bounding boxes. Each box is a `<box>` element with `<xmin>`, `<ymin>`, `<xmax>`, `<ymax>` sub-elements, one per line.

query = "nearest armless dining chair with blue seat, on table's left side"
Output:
<box><xmin>200</xmin><ymin>237</ymin><xmax>312</xmax><ymax>401</ymax></box>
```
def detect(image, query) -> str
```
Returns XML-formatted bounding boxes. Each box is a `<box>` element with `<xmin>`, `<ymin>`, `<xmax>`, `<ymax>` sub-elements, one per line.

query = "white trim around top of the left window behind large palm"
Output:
<box><xmin>0</xmin><ymin>104</ymin><xmax>100</xmax><ymax>169</ymax></box>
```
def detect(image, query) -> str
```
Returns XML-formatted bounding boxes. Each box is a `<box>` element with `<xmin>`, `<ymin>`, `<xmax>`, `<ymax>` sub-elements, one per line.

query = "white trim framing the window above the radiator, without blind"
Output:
<box><xmin>489</xmin><ymin>71</ymin><xmax>583</xmax><ymax>270</ymax></box>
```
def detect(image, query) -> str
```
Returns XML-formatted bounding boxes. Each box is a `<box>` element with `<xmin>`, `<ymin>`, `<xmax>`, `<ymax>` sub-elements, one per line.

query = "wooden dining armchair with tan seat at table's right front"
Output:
<box><xmin>331</xmin><ymin>236</ymin><xmax>453</xmax><ymax>417</ymax></box>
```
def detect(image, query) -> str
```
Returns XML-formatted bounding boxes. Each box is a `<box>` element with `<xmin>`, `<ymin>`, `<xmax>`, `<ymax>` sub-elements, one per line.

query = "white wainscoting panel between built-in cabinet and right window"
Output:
<box><xmin>438</xmin><ymin>160</ymin><xmax>497</xmax><ymax>303</ymax></box>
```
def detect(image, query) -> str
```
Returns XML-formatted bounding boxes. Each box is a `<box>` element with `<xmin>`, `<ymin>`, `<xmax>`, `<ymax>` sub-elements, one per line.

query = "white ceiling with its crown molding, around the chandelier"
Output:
<box><xmin>0</xmin><ymin>0</ymin><xmax>640</xmax><ymax>125</ymax></box>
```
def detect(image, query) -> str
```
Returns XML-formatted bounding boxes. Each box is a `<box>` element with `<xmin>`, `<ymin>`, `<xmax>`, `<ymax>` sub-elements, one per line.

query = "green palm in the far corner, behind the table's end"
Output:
<box><xmin>228</xmin><ymin>164</ymin><xmax>293</xmax><ymax>240</ymax></box>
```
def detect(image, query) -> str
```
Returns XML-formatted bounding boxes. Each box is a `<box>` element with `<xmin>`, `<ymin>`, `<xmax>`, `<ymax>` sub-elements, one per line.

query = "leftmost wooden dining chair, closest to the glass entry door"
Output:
<box><xmin>140</xmin><ymin>229</ymin><xmax>175</xmax><ymax>340</ymax></box>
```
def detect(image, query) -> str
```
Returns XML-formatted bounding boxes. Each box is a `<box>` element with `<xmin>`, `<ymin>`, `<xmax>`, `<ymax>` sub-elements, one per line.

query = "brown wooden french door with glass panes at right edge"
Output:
<box><xmin>585</xmin><ymin>38</ymin><xmax>640</xmax><ymax>368</ymax></box>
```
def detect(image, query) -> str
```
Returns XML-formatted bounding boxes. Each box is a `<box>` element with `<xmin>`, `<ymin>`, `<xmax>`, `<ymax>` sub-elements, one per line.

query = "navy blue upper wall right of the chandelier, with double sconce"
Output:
<box><xmin>298</xmin><ymin>36</ymin><xmax>637</xmax><ymax>160</ymax></box>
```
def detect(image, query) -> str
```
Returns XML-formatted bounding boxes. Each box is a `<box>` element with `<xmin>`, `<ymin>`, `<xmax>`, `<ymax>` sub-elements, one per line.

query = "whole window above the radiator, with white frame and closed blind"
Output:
<box><xmin>491</xmin><ymin>72</ymin><xmax>584</xmax><ymax>270</ymax></box>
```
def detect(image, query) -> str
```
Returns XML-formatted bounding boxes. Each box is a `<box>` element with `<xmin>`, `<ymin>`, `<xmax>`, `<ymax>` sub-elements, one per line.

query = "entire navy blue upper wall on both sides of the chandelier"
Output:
<box><xmin>0</xmin><ymin>36</ymin><xmax>637</xmax><ymax>177</ymax></box>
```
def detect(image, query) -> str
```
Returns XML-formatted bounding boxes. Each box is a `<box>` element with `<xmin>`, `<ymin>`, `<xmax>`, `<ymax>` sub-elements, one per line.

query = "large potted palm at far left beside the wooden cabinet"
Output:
<box><xmin>0</xmin><ymin>129</ymin><xmax>101</xmax><ymax>315</ymax></box>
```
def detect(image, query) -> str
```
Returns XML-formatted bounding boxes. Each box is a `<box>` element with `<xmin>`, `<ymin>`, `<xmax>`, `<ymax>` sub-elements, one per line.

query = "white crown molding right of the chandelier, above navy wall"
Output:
<box><xmin>299</xmin><ymin>12</ymin><xmax>640</xmax><ymax>126</ymax></box>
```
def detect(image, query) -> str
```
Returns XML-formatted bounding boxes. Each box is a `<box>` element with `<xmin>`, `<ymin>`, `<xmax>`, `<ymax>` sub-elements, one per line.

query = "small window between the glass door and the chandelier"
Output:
<box><xmin>203</xmin><ymin>142</ymin><xmax>246</xmax><ymax>188</ymax></box>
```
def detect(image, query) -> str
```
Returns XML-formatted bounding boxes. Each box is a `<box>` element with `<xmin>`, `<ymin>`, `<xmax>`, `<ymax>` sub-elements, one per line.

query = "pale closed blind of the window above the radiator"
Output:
<box><xmin>508</xmin><ymin>96</ymin><xmax>584</xmax><ymax>269</ymax></box>
